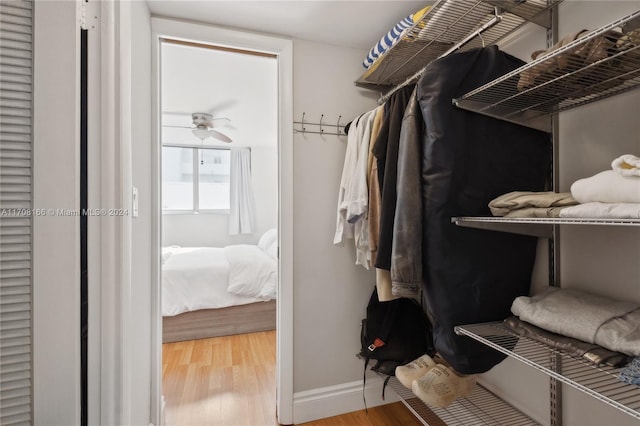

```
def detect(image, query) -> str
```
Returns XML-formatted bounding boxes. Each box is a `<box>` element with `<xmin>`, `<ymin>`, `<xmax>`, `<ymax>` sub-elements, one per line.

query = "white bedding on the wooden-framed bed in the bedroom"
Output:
<box><xmin>162</xmin><ymin>244</ymin><xmax>278</xmax><ymax>316</ymax></box>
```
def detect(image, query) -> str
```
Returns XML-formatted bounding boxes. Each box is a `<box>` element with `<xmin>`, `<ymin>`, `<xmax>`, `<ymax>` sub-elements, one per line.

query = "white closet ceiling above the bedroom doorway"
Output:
<box><xmin>147</xmin><ymin>0</ymin><xmax>433</xmax><ymax>50</ymax></box>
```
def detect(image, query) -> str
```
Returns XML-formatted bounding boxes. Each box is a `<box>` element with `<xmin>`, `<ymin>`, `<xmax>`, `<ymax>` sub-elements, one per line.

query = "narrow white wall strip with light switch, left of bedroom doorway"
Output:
<box><xmin>129</xmin><ymin>1</ymin><xmax>154</xmax><ymax>425</ymax></box>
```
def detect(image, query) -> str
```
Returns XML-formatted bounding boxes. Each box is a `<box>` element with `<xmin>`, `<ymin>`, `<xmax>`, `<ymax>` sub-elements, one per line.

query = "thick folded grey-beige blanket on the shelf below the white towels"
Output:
<box><xmin>511</xmin><ymin>287</ymin><xmax>639</xmax><ymax>344</ymax></box>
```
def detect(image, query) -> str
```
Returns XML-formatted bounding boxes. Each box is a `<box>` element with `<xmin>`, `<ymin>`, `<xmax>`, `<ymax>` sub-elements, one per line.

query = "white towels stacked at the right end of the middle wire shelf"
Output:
<box><xmin>560</xmin><ymin>154</ymin><xmax>640</xmax><ymax>219</ymax></box>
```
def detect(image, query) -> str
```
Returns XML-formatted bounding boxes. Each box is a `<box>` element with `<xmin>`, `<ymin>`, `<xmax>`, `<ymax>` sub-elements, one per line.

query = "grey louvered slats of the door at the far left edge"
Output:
<box><xmin>0</xmin><ymin>0</ymin><xmax>33</xmax><ymax>425</ymax></box>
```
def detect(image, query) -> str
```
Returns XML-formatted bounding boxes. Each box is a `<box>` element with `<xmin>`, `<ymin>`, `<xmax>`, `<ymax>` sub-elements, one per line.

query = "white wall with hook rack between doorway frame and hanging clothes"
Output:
<box><xmin>293</xmin><ymin>40</ymin><xmax>377</xmax><ymax>396</ymax></box>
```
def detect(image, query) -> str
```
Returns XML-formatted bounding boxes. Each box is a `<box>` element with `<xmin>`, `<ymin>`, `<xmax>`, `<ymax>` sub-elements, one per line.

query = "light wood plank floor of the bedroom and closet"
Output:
<box><xmin>162</xmin><ymin>331</ymin><xmax>422</xmax><ymax>426</ymax></box>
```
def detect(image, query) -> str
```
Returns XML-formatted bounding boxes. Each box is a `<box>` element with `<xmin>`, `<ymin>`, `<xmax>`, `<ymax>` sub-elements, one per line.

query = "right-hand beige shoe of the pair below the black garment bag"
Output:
<box><xmin>411</xmin><ymin>364</ymin><xmax>460</xmax><ymax>407</ymax></box>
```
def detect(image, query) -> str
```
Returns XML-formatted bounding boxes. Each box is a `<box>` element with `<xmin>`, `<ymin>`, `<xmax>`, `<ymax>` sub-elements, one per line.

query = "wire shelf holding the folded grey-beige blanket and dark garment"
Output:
<box><xmin>455</xmin><ymin>322</ymin><xmax>640</xmax><ymax>419</ymax></box>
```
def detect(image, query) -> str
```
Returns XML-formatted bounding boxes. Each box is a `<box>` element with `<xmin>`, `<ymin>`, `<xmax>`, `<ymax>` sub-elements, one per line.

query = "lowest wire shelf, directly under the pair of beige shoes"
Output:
<box><xmin>389</xmin><ymin>377</ymin><xmax>539</xmax><ymax>426</ymax></box>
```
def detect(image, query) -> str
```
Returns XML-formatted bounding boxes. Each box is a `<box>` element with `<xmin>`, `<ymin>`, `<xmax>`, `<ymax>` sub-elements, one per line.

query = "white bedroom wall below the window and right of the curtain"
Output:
<box><xmin>162</xmin><ymin>146</ymin><xmax>278</xmax><ymax>247</ymax></box>
